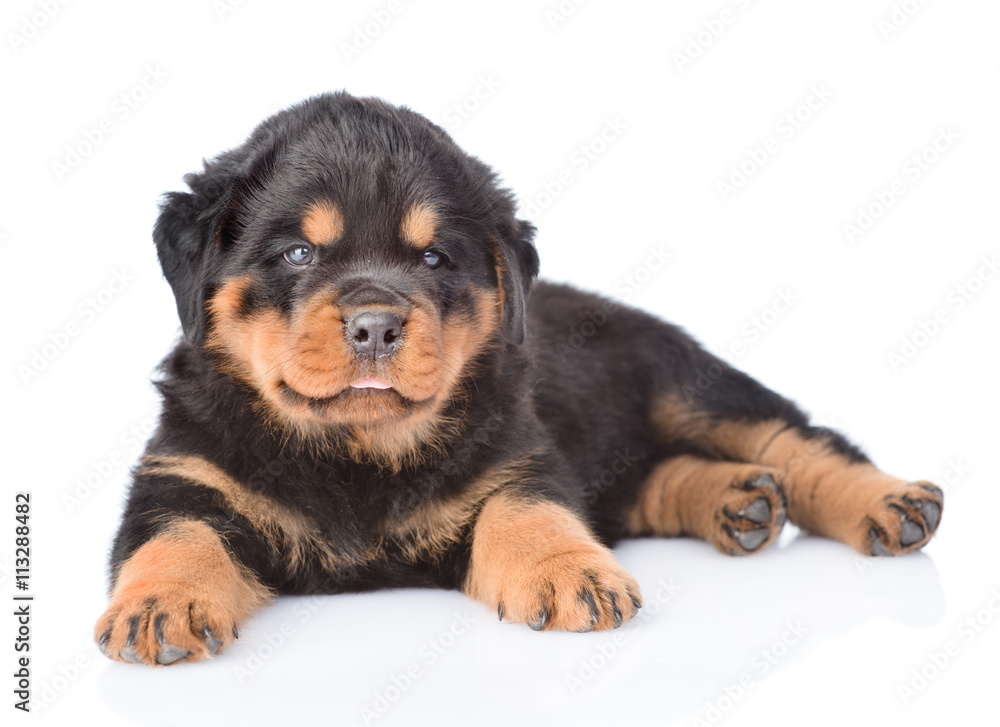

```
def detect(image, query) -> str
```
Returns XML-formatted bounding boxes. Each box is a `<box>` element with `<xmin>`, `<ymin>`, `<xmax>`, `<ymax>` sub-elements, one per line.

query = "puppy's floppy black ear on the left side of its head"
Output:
<box><xmin>153</xmin><ymin>192</ymin><xmax>210</xmax><ymax>345</ymax></box>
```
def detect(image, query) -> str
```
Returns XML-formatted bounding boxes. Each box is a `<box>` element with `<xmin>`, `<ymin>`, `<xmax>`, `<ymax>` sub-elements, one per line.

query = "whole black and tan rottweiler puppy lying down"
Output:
<box><xmin>95</xmin><ymin>93</ymin><xmax>943</xmax><ymax>665</ymax></box>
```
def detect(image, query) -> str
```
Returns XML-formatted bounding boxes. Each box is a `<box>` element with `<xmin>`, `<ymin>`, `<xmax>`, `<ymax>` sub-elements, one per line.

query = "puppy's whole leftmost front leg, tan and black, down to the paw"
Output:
<box><xmin>94</xmin><ymin>454</ymin><xmax>300</xmax><ymax>665</ymax></box>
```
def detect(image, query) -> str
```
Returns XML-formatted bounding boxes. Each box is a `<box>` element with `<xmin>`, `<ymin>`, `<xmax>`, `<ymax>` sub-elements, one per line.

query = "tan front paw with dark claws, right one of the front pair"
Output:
<box><xmin>497</xmin><ymin>543</ymin><xmax>641</xmax><ymax>631</ymax></box>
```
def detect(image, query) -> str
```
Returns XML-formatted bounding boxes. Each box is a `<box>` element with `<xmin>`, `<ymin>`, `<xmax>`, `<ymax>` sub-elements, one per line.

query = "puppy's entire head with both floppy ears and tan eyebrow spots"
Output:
<box><xmin>154</xmin><ymin>94</ymin><xmax>538</xmax><ymax>440</ymax></box>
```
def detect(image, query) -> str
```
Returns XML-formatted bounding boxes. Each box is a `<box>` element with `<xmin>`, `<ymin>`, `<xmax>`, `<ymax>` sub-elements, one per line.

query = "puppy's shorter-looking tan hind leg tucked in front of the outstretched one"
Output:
<box><xmin>629</xmin><ymin>455</ymin><xmax>786</xmax><ymax>555</ymax></box>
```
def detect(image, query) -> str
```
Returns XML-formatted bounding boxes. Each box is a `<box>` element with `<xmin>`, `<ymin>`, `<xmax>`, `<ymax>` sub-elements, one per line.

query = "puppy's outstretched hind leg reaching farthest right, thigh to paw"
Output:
<box><xmin>654</xmin><ymin>392</ymin><xmax>943</xmax><ymax>555</ymax></box>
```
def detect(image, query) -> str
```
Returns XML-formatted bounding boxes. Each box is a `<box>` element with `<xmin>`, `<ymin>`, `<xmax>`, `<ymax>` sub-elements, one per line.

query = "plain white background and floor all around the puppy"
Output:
<box><xmin>0</xmin><ymin>0</ymin><xmax>1000</xmax><ymax>726</ymax></box>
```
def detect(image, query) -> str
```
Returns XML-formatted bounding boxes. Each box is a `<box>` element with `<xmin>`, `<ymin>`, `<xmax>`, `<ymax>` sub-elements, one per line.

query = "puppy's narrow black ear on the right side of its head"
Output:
<box><xmin>494</xmin><ymin>215</ymin><xmax>538</xmax><ymax>345</ymax></box>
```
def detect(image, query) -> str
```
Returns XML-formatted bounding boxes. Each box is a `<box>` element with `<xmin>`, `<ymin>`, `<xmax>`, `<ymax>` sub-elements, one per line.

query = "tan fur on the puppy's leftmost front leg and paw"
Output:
<box><xmin>94</xmin><ymin>520</ymin><xmax>273</xmax><ymax>665</ymax></box>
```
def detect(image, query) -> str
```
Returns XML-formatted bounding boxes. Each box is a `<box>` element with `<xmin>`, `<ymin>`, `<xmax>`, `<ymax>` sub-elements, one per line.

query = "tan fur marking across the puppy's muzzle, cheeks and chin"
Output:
<box><xmin>207</xmin><ymin>277</ymin><xmax>500</xmax><ymax>464</ymax></box>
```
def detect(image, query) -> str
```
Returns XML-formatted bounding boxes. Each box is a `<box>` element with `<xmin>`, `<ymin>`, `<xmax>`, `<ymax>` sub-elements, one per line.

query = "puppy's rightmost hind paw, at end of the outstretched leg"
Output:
<box><xmin>862</xmin><ymin>482</ymin><xmax>944</xmax><ymax>555</ymax></box>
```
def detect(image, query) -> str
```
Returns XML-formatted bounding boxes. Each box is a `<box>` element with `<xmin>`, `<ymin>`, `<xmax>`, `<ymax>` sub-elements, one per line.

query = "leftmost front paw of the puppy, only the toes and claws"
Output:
<box><xmin>95</xmin><ymin>589</ymin><xmax>238</xmax><ymax>665</ymax></box>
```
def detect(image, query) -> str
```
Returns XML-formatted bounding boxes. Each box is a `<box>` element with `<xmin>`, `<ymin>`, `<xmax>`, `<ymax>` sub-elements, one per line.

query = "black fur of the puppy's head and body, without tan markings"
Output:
<box><xmin>112</xmin><ymin>94</ymin><xmax>864</xmax><ymax>593</ymax></box>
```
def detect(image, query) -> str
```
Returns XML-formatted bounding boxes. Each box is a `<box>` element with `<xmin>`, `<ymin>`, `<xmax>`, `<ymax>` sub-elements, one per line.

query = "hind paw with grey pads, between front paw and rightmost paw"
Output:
<box><xmin>715</xmin><ymin>472</ymin><xmax>787</xmax><ymax>555</ymax></box>
